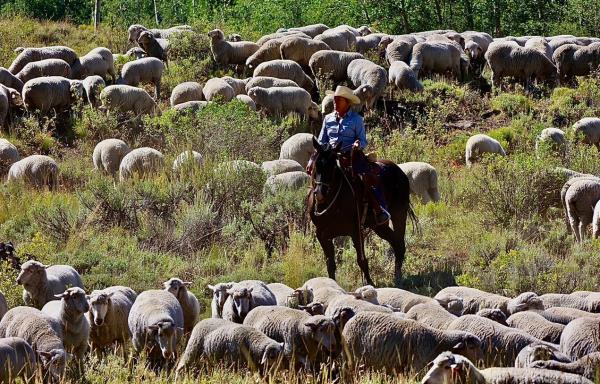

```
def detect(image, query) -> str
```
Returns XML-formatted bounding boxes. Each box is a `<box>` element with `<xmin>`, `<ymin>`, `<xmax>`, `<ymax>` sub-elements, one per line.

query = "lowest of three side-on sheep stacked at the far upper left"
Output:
<box><xmin>22</xmin><ymin>76</ymin><xmax>85</xmax><ymax>113</ymax></box>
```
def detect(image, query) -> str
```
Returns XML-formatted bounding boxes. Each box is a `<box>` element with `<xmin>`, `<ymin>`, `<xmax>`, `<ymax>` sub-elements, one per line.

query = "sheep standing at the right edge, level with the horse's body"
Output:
<box><xmin>564</xmin><ymin>178</ymin><xmax>600</xmax><ymax>242</ymax></box>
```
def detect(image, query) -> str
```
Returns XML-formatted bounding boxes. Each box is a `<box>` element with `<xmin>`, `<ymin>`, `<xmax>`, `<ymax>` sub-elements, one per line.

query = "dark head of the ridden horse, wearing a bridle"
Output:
<box><xmin>312</xmin><ymin>137</ymin><xmax>341</xmax><ymax>204</ymax></box>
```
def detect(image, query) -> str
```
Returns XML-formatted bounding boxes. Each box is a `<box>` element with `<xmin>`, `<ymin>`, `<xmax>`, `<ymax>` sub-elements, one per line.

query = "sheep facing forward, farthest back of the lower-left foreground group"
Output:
<box><xmin>17</xmin><ymin>260</ymin><xmax>83</xmax><ymax>309</ymax></box>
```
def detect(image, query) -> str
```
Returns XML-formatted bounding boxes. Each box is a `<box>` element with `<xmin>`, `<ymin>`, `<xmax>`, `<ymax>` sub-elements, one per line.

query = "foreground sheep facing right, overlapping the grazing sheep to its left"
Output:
<box><xmin>244</xmin><ymin>306</ymin><xmax>337</xmax><ymax>367</ymax></box>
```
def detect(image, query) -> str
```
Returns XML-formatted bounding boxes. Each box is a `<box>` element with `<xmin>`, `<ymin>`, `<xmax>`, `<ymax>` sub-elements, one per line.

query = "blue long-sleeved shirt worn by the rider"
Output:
<box><xmin>319</xmin><ymin>110</ymin><xmax>367</xmax><ymax>152</ymax></box>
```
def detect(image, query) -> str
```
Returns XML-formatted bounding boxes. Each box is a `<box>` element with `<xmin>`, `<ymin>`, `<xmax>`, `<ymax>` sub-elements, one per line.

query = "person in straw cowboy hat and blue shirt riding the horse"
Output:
<box><xmin>306</xmin><ymin>86</ymin><xmax>390</xmax><ymax>225</ymax></box>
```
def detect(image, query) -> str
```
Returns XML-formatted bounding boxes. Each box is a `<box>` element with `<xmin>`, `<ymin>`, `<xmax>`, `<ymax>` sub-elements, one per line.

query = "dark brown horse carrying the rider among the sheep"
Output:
<box><xmin>307</xmin><ymin>138</ymin><xmax>417</xmax><ymax>287</ymax></box>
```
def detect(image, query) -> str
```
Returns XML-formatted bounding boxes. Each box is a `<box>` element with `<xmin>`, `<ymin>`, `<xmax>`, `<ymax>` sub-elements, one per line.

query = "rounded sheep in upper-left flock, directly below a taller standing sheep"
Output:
<box><xmin>100</xmin><ymin>85</ymin><xmax>158</xmax><ymax>116</ymax></box>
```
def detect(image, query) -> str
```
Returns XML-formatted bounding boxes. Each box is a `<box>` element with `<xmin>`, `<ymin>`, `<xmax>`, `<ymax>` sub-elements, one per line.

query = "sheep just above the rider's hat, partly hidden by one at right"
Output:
<box><xmin>308</xmin><ymin>51</ymin><xmax>365</xmax><ymax>89</ymax></box>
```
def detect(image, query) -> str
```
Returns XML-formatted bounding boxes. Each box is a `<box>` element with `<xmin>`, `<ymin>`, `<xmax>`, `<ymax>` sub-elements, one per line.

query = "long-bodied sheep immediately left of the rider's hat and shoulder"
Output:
<box><xmin>248</xmin><ymin>87</ymin><xmax>319</xmax><ymax>120</ymax></box>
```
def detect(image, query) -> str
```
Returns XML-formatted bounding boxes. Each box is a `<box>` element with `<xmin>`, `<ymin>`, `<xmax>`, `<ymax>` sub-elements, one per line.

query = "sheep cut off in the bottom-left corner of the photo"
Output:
<box><xmin>0</xmin><ymin>337</ymin><xmax>36</xmax><ymax>383</ymax></box>
